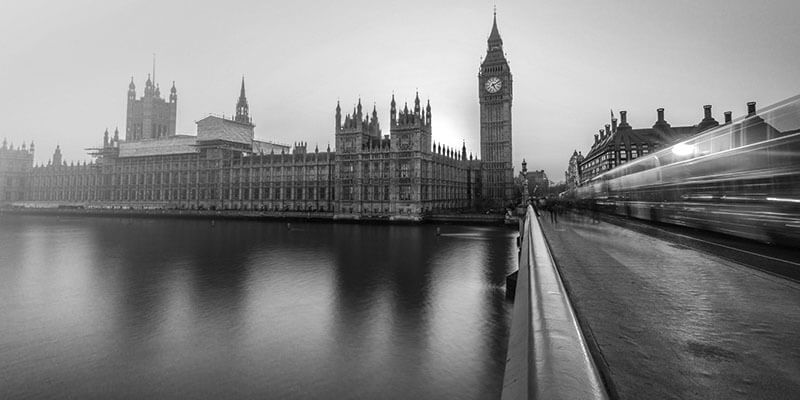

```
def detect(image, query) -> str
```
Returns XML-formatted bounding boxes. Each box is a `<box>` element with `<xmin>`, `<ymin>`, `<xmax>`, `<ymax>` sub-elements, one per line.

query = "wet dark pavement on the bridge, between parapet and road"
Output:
<box><xmin>540</xmin><ymin>213</ymin><xmax>800</xmax><ymax>399</ymax></box>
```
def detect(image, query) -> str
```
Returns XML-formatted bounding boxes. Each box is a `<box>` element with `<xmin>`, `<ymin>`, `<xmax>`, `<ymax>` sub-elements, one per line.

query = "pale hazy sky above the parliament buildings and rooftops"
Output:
<box><xmin>0</xmin><ymin>0</ymin><xmax>800</xmax><ymax>181</ymax></box>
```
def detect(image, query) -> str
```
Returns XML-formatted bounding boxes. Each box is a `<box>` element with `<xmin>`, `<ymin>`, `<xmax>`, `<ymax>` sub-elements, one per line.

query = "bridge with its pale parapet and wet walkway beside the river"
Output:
<box><xmin>503</xmin><ymin>207</ymin><xmax>800</xmax><ymax>399</ymax></box>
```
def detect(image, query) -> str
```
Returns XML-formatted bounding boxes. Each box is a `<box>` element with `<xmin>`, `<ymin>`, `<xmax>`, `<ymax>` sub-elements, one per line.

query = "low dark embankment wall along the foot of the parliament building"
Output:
<box><xmin>0</xmin><ymin>208</ymin><xmax>504</xmax><ymax>225</ymax></box>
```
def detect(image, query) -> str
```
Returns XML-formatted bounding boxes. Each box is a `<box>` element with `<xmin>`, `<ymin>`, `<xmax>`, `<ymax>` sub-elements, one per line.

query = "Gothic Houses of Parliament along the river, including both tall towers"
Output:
<box><xmin>0</xmin><ymin>16</ymin><xmax>514</xmax><ymax>220</ymax></box>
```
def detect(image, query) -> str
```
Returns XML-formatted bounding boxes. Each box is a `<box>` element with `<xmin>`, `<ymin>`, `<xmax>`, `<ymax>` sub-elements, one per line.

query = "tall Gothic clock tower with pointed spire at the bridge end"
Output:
<box><xmin>478</xmin><ymin>13</ymin><xmax>514</xmax><ymax>207</ymax></box>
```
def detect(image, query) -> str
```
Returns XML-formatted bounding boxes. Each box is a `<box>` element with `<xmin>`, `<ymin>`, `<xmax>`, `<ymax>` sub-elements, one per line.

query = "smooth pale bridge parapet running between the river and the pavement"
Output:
<box><xmin>502</xmin><ymin>206</ymin><xmax>608</xmax><ymax>400</ymax></box>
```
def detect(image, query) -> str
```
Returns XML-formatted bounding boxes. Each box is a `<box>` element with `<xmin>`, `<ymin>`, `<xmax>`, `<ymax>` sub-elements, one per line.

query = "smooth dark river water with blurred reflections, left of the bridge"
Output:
<box><xmin>0</xmin><ymin>215</ymin><xmax>516</xmax><ymax>399</ymax></box>
